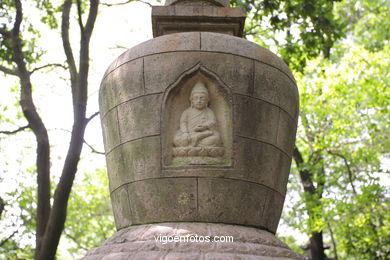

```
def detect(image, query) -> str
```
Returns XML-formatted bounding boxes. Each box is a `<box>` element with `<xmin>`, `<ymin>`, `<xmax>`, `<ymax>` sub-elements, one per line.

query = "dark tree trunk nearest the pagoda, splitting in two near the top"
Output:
<box><xmin>36</xmin><ymin>0</ymin><xmax>99</xmax><ymax>260</ymax></box>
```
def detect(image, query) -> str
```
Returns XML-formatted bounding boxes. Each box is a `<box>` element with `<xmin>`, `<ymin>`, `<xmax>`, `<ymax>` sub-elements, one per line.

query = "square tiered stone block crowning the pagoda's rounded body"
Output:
<box><xmin>152</xmin><ymin>0</ymin><xmax>246</xmax><ymax>37</ymax></box>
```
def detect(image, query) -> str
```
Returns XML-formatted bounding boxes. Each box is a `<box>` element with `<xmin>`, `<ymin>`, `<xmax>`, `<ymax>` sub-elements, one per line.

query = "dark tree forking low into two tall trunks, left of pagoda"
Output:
<box><xmin>0</xmin><ymin>0</ymin><xmax>99</xmax><ymax>259</ymax></box>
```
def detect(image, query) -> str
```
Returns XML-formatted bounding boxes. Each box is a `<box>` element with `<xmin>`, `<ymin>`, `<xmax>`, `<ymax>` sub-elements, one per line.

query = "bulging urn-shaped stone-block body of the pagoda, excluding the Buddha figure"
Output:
<box><xmin>101</xmin><ymin>32</ymin><xmax>298</xmax><ymax>236</ymax></box>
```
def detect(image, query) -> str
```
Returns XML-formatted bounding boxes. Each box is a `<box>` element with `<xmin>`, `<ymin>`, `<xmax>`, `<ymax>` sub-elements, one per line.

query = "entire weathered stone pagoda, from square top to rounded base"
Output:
<box><xmin>83</xmin><ymin>0</ymin><xmax>302</xmax><ymax>260</ymax></box>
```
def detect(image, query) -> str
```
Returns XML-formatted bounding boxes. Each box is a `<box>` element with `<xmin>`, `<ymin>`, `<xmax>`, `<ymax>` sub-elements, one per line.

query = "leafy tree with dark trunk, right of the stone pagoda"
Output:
<box><xmin>234</xmin><ymin>0</ymin><xmax>389</xmax><ymax>259</ymax></box>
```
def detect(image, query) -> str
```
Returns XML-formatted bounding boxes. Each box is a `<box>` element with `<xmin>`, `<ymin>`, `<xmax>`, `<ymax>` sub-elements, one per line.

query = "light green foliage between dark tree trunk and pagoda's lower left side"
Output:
<box><xmin>59</xmin><ymin>170</ymin><xmax>115</xmax><ymax>257</ymax></box>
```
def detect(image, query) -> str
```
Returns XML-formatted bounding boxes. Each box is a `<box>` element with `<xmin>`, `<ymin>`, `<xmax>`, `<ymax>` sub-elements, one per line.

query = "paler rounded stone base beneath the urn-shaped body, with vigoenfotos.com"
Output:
<box><xmin>82</xmin><ymin>222</ymin><xmax>305</xmax><ymax>260</ymax></box>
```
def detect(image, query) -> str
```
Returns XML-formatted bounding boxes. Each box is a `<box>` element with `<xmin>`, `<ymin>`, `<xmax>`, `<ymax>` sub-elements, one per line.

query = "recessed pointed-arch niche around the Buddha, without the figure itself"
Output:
<box><xmin>161</xmin><ymin>64</ymin><xmax>233</xmax><ymax>167</ymax></box>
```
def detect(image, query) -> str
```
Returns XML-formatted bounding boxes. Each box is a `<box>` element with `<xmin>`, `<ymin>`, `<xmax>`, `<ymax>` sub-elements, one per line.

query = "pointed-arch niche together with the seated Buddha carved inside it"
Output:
<box><xmin>161</xmin><ymin>67</ymin><xmax>233</xmax><ymax>169</ymax></box>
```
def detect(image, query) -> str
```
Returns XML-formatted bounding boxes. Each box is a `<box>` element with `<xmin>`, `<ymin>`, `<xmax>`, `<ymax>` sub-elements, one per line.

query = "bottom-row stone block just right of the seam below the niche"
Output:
<box><xmin>198</xmin><ymin>178</ymin><xmax>268</xmax><ymax>227</ymax></box>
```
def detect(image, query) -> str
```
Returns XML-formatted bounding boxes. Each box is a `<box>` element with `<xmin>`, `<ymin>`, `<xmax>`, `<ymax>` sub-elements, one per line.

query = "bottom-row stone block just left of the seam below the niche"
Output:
<box><xmin>128</xmin><ymin>178</ymin><xmax>197</xmax><ymax>224</ymax></box>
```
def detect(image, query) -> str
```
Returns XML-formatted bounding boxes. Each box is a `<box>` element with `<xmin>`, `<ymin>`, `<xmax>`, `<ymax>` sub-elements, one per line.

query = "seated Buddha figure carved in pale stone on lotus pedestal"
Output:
<box><xmin>173</xmin><ymin>81</ymin><xmax>225</xmax><ymax>157</ymax></box>
